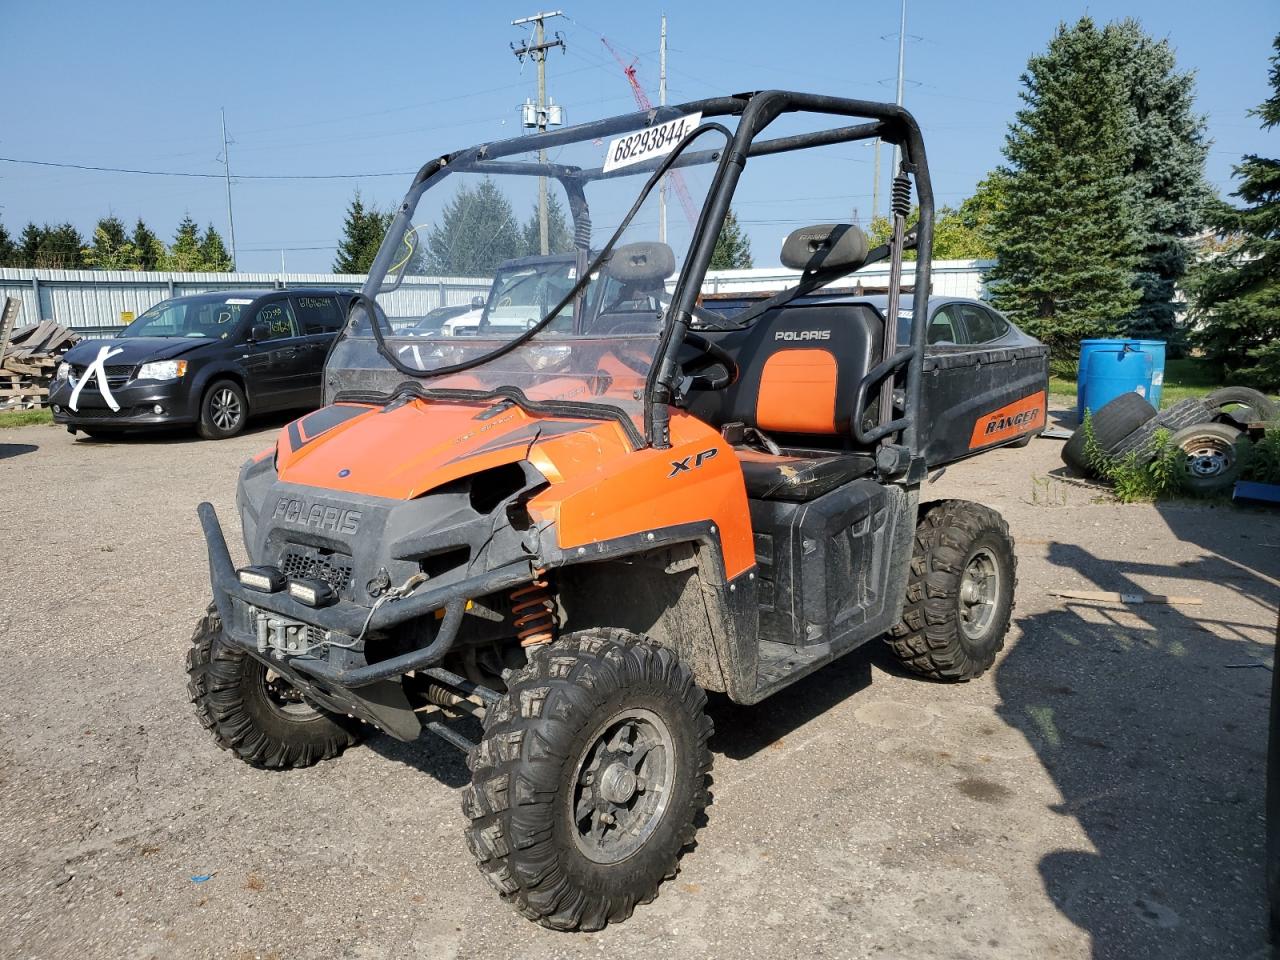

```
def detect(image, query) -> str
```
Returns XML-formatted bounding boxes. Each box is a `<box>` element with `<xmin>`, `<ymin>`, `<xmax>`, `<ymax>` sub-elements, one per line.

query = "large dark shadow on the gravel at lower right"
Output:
<box><xmin>996</xmin><ymin>522</ymin><xmax>1277</xmax><ymax>959</ymax></box>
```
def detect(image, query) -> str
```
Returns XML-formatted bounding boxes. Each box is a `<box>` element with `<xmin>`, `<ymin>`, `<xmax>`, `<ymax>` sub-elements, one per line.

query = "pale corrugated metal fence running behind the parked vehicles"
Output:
<box><xmin>0</xmin><ymin>260</ymin><xmax>992</xmax><ymax>329</ymax></box>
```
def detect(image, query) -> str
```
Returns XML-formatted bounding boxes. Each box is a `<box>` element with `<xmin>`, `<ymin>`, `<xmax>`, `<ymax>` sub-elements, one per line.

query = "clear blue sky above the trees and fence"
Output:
<box><xmin>0</xmin><ymin>0</ymin><xmax>1280</xmax><ymax>270</ymax></box>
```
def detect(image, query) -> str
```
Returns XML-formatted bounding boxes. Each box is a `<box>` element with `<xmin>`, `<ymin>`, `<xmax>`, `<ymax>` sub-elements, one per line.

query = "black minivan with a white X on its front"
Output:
<box><xmin>49</xmin><ymin>288</ymin><xmax>353</xmax><ymax>440</ymax></box>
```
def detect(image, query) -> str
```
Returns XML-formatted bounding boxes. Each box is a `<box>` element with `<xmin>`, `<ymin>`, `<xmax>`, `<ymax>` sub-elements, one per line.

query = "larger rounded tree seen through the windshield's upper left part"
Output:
<box><xmin>425</xmin><ymin>177</ymin><xmax>525</xmax><ymax>276</ymax></box>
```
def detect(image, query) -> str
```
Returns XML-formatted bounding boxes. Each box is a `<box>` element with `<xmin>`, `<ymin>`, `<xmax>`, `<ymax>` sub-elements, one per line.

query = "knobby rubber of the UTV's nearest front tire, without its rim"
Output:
<box><xmin>462</xmin><ymin>628</ymin><xmax>712</xmax><ymax>931</ymax></box>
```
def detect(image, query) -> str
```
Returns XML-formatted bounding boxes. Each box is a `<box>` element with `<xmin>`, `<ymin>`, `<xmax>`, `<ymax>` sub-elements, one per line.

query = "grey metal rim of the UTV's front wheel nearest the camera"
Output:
<box><xmin>567</xmin><ymin>708</ymin><xmax>676</xmax><ymax>864</ymax></box>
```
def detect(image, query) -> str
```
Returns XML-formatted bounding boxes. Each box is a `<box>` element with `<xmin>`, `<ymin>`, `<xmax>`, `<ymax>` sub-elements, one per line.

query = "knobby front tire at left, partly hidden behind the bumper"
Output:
<box><xmin>187</xmin><ymin>605</ymin><xmax>366</xmax><ymax>771</ymax></box>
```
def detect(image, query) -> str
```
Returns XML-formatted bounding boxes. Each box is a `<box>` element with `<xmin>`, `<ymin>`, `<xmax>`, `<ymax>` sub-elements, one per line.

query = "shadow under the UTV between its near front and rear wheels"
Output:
<box><xmin>707</xmin><ymin>650</ymin><xmax>883</xmax><ymax>760</ymax></box>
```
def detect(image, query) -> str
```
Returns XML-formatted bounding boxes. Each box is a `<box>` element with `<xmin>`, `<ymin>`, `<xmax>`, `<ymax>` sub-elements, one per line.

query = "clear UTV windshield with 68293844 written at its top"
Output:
<box><xmin>326</xmin><ymin>114</ymin><xmax>724</xmax><ymax>432</ymax></box>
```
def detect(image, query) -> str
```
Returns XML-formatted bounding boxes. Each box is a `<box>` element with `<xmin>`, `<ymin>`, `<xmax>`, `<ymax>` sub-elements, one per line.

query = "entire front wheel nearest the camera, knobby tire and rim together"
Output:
<box><xmin>462</xmin><ymin>630</ymin><xmax>712</xmax><ymax>931</ymax></box>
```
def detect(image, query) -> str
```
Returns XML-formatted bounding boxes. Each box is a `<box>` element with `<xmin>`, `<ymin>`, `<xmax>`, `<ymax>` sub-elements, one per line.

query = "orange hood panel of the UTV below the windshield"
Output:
<box><xmin>276</xmin><ymin>399</ymin><xmax>630</xmax><ymax>500</ymax></box>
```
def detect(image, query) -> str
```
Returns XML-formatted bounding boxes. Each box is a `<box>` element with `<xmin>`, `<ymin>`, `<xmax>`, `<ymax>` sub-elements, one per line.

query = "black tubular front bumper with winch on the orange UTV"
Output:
<box><xmin>197</xmin><ymin>503</ymin><xmax>532</xmax><ymax>740</ymax></box>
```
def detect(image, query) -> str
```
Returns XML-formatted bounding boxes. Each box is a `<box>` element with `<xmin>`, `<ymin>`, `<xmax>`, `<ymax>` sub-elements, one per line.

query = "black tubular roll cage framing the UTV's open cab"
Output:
<box><xmin>364</xmin><ymin>90</ymin><xmax>934</xmax><ymax>483</ymax></box>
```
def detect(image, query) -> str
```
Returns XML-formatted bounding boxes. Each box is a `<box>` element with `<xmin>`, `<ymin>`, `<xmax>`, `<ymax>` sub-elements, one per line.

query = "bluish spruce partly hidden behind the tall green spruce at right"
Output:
<box><xmin>1105</xmin><ymin>19</ymin><xmax>1212</xmax><ymax>340</ymax></box>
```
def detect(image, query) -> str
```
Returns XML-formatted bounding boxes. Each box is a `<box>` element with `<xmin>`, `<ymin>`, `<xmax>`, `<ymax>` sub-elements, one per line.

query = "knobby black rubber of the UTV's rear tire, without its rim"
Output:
<box><xmin>886</xmin><ymin>500</ymin><xmax>1018</xmax><ymax>682</ymax></box>
